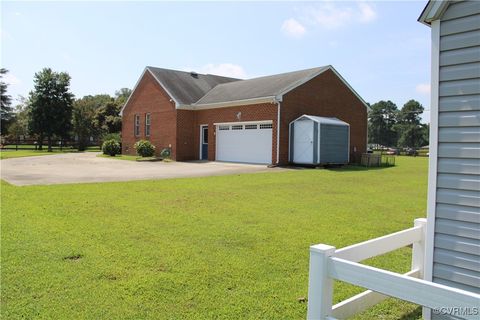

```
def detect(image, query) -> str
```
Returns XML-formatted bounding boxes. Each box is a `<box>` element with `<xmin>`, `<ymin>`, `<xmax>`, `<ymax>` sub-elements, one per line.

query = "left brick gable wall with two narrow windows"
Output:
<box><xmin>122</xmin><ymin>71</ymin><xmax>177</xmax><ymax>159</ymax></box>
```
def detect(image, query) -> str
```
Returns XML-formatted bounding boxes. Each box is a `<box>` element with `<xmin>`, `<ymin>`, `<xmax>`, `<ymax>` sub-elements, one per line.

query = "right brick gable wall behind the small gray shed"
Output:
<box><xmin>280</xmin><ymin>70</ymin><xmax>367</xmax><ymax>164</ymax></box>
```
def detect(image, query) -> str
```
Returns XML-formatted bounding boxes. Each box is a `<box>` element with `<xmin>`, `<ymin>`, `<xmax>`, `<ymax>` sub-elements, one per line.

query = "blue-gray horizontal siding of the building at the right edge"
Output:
<box><xmin>432</xmin><ymin>1</ymin><xmax>480</xmax><ymax>300</ymax></box>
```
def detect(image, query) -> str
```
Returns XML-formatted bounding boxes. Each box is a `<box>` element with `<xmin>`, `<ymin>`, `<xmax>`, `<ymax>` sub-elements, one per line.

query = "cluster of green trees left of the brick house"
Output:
<box><xmin>0</xmin><ymin>68</ymin><xmax>132</xmax><ymax>151</ymax></box>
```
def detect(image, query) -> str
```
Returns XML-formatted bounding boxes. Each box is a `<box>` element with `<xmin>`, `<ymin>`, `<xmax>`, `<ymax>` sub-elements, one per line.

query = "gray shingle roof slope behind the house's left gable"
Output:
<box><xmin>147</xmin><ymin>67</ymin><xmax>240</xmax><ymax>105</ymax></box>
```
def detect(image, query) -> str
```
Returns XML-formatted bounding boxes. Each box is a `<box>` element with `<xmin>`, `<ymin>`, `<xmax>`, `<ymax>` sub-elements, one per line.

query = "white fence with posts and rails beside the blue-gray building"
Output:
<box><xmin>307</xmin><ymin>219</ymin><xmax>480</xmax><ymax>320</ymax></box>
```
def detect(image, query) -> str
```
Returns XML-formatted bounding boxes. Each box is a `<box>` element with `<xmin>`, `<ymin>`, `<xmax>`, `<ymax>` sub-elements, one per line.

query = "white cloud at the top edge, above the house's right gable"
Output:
<box><xmin>302</xmin><ymin>1</ymin><xmax>377</xmax><ymax>30</ymax></box>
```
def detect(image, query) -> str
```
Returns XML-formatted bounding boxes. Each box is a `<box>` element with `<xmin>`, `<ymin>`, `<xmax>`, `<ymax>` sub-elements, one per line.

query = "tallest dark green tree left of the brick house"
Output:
<box><xmin>29</xmin><ymin>68</ymin><xmax>74</xmax><ymax>151</ymax></box>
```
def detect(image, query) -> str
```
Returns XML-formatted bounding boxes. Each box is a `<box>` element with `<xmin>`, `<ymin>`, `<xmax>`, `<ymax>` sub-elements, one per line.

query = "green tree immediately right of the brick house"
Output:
<box><xmin>368</xmin><ymin>100</ymin><xmax>398</xmax><ymax>146</ymax></box>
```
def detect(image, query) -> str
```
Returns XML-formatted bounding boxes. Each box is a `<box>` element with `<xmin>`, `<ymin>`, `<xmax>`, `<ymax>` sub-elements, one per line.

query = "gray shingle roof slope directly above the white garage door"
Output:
<box><xmin>195</xmin><ymin>66</ymin><xmax>328</xmax><ymax>105</ymax></box>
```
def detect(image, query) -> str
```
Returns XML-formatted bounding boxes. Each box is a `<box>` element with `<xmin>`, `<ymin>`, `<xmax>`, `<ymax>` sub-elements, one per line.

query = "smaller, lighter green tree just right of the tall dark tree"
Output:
<box><xmin>72</xmin><ymin>96</ymin><xmax>98</xmax><ymax>151</ymax></box>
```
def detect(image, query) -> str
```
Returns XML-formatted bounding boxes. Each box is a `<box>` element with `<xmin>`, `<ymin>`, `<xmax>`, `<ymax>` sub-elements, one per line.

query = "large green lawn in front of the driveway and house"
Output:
<box><xmin>1</xmin><ymin>157</ymin><xmax>427</xmax><ymax>319</ymax></box>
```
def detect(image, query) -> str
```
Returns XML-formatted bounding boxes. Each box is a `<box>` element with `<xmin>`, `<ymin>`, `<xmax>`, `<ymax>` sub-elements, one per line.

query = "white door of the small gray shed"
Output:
<box><xmin>293</xmin><ymin>120</ymin><xmax>314</xmax><ymax>164</ymax></box>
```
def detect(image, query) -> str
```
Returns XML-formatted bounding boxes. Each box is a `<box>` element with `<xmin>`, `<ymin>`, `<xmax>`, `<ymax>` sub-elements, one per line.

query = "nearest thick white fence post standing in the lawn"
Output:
<box><xmin>307</xmin><ymin>244</ymin><xmax>335</xmax><ymax>320</ymax></box>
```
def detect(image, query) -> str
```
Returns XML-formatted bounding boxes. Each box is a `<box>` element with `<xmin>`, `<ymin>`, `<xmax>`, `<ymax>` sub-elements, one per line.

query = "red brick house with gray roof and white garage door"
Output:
<box><xmin>121</xmin><ymin>66</ymin><xmax>368</xmax><ymax>164</ymax></box>
